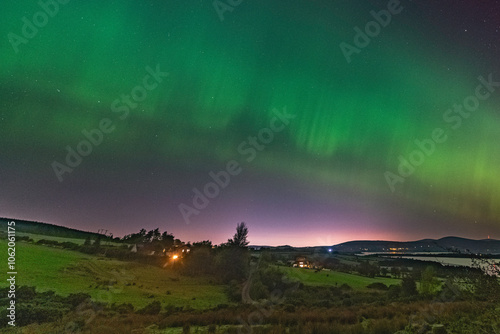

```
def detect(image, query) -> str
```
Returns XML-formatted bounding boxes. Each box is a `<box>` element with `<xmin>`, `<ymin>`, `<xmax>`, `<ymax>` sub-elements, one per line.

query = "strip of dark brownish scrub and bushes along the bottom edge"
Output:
<box><xmin>2</xmin><ymin>287</ymin><xmax>500</xmax><ymax>334</ymax></box>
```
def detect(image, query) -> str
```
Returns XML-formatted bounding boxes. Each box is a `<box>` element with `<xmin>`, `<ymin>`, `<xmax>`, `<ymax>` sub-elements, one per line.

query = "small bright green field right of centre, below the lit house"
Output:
<box><xmin>280</xmin><ymin>267</ymin><xmax>401</xmax><ymax>290</ymax></box>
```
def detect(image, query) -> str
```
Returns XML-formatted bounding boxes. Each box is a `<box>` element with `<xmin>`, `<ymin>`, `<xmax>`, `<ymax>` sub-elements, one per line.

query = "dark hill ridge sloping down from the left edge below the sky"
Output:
<box><xmin>0</xmin><ymin>218</ymin><xmax>106</xmax><ymax>239</ymax></box>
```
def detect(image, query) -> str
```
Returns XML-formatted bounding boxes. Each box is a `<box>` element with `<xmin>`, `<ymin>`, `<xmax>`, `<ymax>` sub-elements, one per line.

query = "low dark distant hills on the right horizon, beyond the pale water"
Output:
<box><xmin>333</xmin><ymin>237</ymin><xmax>500</xmax><ymax>254</ymax></box>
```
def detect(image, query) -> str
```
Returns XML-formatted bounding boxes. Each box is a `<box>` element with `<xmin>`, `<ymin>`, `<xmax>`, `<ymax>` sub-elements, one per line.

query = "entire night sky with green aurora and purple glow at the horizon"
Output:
<box><xmin>0</xmin><ymin>0</ymin><xmax>500</xmax><ymax>246</ymax></box>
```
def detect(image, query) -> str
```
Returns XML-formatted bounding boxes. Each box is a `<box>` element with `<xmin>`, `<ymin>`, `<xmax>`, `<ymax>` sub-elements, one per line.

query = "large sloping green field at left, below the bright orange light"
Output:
<box><xmin>0</xmin><ymin>240</ymin><xmax>228</xmax><ymax>309</ymax></box>
